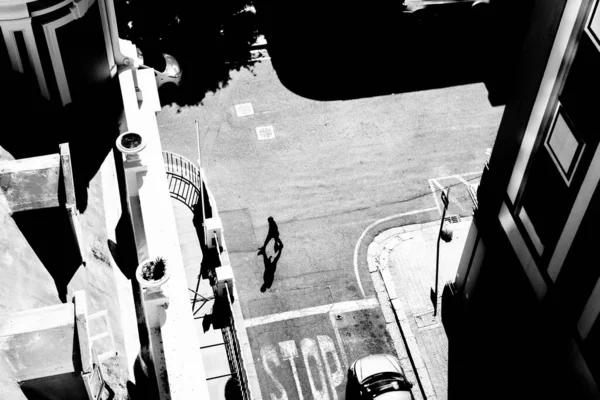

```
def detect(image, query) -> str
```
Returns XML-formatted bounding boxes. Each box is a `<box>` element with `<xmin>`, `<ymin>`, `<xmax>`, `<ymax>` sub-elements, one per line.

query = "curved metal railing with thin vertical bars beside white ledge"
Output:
<box><xmin>163</xmin><ymin>151</ymin><xmax>202</xmax><ymax>211</ymax></box>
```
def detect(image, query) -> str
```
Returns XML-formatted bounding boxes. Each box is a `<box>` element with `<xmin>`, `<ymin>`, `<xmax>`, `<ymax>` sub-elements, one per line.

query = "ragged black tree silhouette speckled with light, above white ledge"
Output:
<box><xmin>115</xmin><ymin>0</ymin><xmax>261</xmax><ymax>106</ymax></box>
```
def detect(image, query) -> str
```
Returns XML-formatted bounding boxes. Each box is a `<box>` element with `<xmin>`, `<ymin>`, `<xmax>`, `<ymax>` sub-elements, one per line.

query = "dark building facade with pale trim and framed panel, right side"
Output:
<box><xmin>450</xmin><ymin>0</ymin><xmax>600</xmax><ymax>399</ymax></box>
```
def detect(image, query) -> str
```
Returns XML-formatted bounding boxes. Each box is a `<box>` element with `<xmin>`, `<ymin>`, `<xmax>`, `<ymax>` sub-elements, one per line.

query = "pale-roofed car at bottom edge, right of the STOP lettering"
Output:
<box><xmin>346</xmin><ymin>354</ymin><xmax>413</xmax><ymax>400</ymax></box>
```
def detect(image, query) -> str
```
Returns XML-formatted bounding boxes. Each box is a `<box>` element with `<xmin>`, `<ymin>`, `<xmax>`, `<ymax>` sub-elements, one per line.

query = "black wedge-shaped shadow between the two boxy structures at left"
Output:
<box><xmin>13</xmin><ymin>207</ymin><xmax>82</xmax><ymax>303</ymax></box>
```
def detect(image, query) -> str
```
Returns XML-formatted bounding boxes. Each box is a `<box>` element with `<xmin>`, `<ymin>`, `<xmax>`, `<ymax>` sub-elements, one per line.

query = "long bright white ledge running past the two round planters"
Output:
<box><xmin>119</xmin><ymin>65</ymin><xmax>209</xmax><ymax>400</ymax></box>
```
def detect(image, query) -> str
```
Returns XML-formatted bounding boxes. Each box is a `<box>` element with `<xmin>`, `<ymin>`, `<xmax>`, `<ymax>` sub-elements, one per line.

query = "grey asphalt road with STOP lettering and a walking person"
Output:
<box><xmin>158</xmin><ymin>57</ymin><xmax>503</xmax><ymax>400</ymax></box>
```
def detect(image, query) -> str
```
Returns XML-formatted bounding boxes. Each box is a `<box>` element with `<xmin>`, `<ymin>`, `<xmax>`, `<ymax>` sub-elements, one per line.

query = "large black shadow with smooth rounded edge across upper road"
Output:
<box><xmin>256</xmin><ymin>0</ymin><xmax>530</xmax><ymax>103</ymax></box>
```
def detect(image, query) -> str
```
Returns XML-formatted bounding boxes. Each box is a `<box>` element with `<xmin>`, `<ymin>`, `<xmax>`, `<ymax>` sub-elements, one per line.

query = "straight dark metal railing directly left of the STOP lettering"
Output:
<box><xmin>222</xmin><ymin>285</ymin><xmax>252</xmax><ymax>400</ymax></box>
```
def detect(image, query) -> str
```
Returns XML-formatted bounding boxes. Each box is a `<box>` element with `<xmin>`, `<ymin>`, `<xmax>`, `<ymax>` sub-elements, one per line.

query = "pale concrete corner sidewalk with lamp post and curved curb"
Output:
<box><xmin>367</xmin><ymin>217</ymin><xmax>472</xmax><ymax>400</ymax></box>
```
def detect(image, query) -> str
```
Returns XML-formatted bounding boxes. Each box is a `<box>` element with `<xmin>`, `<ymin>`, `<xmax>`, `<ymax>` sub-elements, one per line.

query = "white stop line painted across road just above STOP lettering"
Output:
<box><xmin>244</xmin><ymin>297</ymin><xmax>379</xmax><ymax>328</ymax></box>
